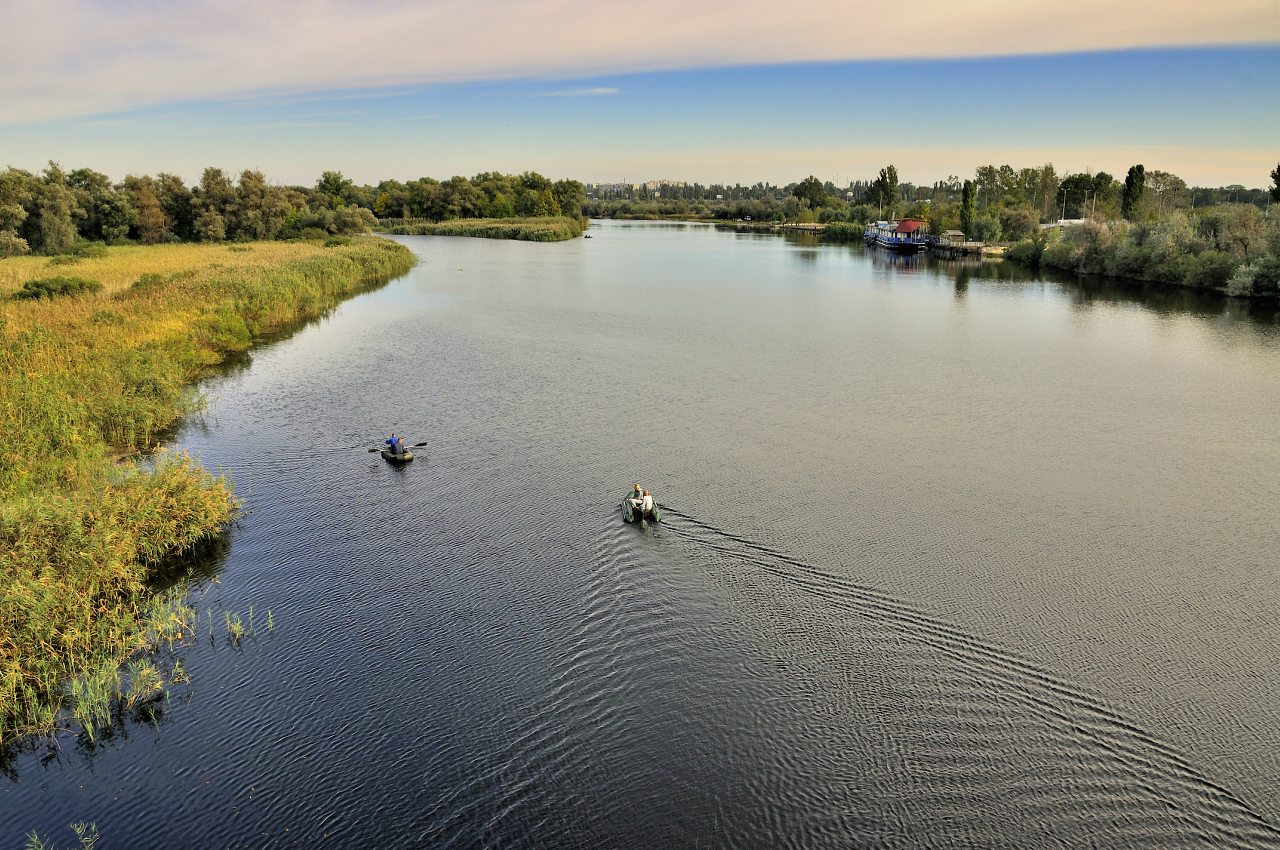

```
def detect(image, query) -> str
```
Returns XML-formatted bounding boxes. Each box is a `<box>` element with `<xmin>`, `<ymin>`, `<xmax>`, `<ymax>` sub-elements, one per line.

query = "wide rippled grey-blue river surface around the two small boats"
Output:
<box><xmin>10</xmin><ymin>224</ymin><xmax>1280</xmax><ymax>847</ymax></box>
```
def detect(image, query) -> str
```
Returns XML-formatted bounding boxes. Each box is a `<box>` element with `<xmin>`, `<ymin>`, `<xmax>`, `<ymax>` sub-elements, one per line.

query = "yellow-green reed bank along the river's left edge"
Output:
<box><xmin>0</xmin><ymin>238</ymin><xmax>413</xmax><ymax>745</ymax></box>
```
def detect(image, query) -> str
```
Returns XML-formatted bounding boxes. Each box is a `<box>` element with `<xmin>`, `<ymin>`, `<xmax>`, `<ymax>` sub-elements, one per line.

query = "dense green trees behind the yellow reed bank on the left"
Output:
<box><xmin>0</xmin><ymin>163</ymin><xmax>585</xmax><ymax>257</ymax></box>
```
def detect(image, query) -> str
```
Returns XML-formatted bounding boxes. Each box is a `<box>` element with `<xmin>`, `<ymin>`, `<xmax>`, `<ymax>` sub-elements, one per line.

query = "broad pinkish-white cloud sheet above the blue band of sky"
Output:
<box><xmin>0</xmin><ymin>0</ymin><xmax>1280</xmax><ymax>124</ymax></box>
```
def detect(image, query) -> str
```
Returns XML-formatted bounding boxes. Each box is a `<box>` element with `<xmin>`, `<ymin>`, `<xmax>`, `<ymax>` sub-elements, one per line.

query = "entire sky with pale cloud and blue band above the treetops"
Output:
<box><xmin>0</xmin><ymin>0</ymin><xmax>1280</xmax><ymax>187</ymax></box>
